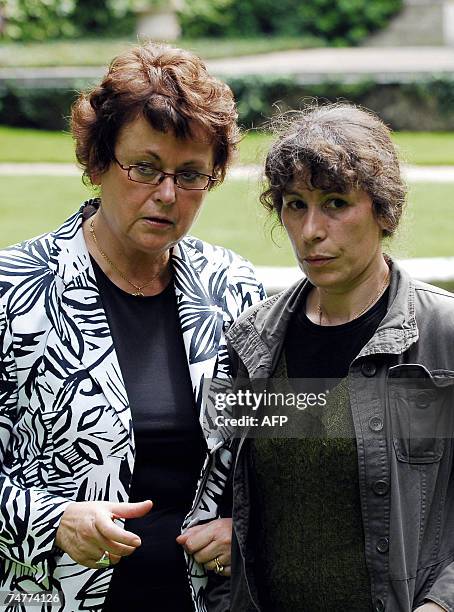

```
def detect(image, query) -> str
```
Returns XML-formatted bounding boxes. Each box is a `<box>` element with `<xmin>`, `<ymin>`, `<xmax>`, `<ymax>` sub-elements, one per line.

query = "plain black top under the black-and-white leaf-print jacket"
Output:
<box><xmin>92</xmin><ymin>259</ymin><xmax>206</xmax><ymax>612</ymax></box>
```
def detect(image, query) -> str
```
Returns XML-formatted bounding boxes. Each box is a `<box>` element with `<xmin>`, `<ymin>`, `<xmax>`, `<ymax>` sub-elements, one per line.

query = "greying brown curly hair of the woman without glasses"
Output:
<box><xmin>260</xmin><ymin>103</ymin><xmax>407</xmax><ymax>236</ymax></box>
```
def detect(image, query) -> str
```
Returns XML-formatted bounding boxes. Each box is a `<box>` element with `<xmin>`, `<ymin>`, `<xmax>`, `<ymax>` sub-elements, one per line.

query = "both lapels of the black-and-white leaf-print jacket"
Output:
<box><xmin>48</xmin><ymin>200</ymin><xmax>223</xmax><ymax>438</ymax></box>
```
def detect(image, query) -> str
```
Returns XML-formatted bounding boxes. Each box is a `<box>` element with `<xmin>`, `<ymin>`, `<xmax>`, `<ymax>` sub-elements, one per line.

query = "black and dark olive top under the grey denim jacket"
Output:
<box><xmin>251</xmin><ymin>292</ymin><xmax>388</xmax><ymax>612</ymax></box>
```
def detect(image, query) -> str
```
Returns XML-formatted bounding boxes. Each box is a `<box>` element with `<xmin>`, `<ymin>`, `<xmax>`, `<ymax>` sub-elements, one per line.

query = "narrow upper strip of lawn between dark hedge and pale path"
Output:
<box><xmin>0</xmin><ymin>126</ymin><xmax>454</xmax><ymax>166</ymax></box>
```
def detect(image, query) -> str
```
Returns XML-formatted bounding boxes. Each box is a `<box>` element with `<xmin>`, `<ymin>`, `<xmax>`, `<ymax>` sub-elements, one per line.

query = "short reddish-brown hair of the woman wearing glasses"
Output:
<box><xmin>71</xmin><ymin>42</ymin><xmax>240</xmax><ymax>182</ymax></box>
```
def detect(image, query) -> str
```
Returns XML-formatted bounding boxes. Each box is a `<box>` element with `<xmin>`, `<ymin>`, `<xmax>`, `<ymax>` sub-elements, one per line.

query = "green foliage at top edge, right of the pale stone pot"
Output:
<box><xmin>180</xmin><ymin>0</ymin><xmax>403</xmax><ymax>45</ymax></box>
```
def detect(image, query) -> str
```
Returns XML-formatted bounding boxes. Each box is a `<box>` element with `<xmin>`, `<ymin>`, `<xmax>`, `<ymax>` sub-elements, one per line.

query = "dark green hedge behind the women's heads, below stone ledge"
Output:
<box><xmin>0</xmin><ymin>76</ymin><xmax>454</xmax><ymax>131</ymax></box>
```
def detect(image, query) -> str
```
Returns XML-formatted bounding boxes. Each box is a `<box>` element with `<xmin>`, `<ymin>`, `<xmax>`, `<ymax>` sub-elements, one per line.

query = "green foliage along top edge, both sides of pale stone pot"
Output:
<box><xmin>0</xmin><ymin>0</ymin><xmax>403</xmax><ymax>45</ymax></box>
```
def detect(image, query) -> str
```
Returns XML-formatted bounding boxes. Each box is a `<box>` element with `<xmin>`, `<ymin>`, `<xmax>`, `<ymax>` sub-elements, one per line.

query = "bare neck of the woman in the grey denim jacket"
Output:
<box><xmin>306</xmin><ymin>256</ymin><xmax>390</xmax><ymax>325</ymax></box>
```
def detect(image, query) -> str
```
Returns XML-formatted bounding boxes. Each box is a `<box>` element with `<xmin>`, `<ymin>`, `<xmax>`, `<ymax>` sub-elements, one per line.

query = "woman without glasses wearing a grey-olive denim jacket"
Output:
<box><xmin>228</xmin><ymin>104</ymin><xmax>454</xmax><ymax>612</ymax></box>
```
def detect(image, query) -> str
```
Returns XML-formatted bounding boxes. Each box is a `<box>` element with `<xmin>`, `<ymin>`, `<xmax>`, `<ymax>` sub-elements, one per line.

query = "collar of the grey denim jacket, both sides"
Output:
<box><xmin>227</xmin><ymin>260</ymin><xmax>419</xmax><ymax>378</ymax></box>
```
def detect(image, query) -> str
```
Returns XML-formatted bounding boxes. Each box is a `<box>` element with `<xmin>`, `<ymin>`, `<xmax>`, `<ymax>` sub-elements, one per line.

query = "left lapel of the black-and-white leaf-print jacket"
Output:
<box><xmin>51</xmin><ymin>212</ymin><xmax>132</xmax><ymax>432</ymax></box>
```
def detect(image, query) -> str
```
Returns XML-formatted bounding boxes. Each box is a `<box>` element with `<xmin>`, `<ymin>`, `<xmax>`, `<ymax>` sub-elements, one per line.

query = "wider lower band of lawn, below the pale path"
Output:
<box><xmin>0</xmin><ymin>176</ymin><xmax>454</xmax><ymax>265</ymax></box>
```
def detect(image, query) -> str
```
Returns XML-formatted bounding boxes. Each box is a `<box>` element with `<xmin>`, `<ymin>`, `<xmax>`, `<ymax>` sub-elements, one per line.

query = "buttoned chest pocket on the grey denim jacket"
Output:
<box><xmin>388</xmin><ymin>364</ymin><xmax>454</xmax><ymax>464</ymax></box>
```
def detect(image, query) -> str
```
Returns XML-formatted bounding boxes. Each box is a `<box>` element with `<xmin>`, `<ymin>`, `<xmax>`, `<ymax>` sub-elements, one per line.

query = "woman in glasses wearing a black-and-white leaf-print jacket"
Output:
<box><xmin>0</xmin><ymin>43</ymin><xmax>263</xmax><ymax>612</ymax></box>
